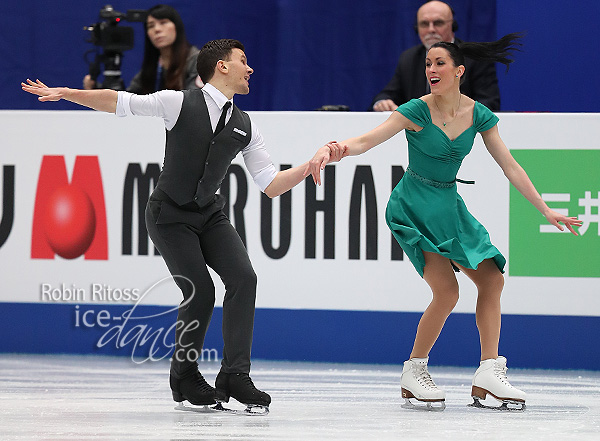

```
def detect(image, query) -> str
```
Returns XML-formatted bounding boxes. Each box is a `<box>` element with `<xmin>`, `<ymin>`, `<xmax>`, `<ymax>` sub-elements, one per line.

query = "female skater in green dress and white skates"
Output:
<box><xmin>309</xmin><ymin>34</ymin><xmax>581</xmax><ymax>409</ymax></box>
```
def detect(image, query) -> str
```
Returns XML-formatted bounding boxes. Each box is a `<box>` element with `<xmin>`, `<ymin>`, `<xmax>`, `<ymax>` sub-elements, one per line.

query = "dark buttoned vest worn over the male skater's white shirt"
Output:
<box><xmin>156</xmin><ymin>90</ymin><xmax>252</xmax><ymax>207</ymax></box>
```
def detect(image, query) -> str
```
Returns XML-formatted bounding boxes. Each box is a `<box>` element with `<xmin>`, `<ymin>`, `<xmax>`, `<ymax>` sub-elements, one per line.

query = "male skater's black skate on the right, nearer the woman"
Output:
<box><xmin>215</xmin><ymin>372</ymin><xmax>271</xmax><ymax>415</ymax></box>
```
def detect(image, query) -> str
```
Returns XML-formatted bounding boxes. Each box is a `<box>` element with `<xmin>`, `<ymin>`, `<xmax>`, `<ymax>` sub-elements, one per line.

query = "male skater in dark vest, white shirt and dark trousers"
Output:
<box><xmin>21</xmin><ymin>39</ymin><xmax>343</xmax><ymax>411</ymax></box>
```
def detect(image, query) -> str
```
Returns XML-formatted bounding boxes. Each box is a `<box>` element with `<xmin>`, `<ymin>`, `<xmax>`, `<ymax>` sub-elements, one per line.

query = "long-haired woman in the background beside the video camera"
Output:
<box><xmin>83</xmin><ymin>5</ymin><xmax>203</xmax><ymax>95</ymax></box>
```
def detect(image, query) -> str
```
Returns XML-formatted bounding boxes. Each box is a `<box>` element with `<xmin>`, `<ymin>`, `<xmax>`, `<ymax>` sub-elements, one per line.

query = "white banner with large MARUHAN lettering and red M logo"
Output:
<box><xmin>0</xmin><ymin>110</ymin><xmax>600</xmax><ymax>316</ymax></box>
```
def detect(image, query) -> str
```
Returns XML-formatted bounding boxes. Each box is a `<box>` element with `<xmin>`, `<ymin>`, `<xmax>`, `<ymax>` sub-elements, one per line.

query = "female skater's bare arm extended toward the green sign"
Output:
<box><xmin>481</xmin><ymin>125</ymin><xmax>582</xmax><ymax>236</ymax></box>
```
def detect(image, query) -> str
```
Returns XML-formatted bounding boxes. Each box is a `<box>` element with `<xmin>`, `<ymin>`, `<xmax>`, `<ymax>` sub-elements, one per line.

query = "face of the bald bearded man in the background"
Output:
<box><xmin>417</xmin><ymin>1</ymin><xmax>454</xmax><ymax>49</ymax></box>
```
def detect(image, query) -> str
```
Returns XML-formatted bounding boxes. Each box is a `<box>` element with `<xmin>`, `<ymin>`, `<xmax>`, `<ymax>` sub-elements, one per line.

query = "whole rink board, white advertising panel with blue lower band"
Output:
<box><xmin>0</xmin><ymin>111</ymin><xmax>600</xmax><ymax>369</ymax></box>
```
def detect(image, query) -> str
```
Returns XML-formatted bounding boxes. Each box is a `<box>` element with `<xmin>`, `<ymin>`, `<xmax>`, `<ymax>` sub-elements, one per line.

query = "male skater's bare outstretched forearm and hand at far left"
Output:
<box><xmin>21</xmin><ymin>79</ymin><xmax>117</xmax><ymax>113</ymax></box>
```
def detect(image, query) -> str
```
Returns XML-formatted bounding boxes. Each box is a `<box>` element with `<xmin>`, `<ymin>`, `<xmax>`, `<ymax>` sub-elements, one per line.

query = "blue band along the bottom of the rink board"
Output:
<box><xmin>0</xmin><ymin>303</ymin><xmax>600</xmax><ymax>370</ymax></box>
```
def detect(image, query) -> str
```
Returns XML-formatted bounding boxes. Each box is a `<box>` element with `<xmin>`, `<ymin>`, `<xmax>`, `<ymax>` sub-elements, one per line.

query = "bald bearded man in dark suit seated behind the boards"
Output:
<box><xmin>371</xmin><ymin>1</ymin><xmax>500</xmax><ymax>112</ymax></box>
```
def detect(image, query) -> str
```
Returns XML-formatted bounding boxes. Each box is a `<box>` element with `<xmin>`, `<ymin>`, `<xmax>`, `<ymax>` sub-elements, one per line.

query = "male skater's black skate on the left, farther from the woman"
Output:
<box><xmin>169</xmin><ymin>371</ymin><xmax>216</xmax><ymax>412</ymax></box>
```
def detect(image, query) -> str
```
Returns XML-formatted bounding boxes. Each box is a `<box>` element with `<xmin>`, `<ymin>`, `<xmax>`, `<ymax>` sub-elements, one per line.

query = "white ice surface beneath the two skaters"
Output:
<box><xmin>0</xmin><ymin>354</ymin><xmax>600</xmax><ymax>441</ymax></box>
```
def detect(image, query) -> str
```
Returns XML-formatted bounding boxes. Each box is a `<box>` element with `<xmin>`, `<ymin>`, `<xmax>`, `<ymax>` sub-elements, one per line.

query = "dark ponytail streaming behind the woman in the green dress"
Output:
<box><xmin>429</xmin><ymin>32</ymin><xmax>523</xmax><ymax>80</ymax></box>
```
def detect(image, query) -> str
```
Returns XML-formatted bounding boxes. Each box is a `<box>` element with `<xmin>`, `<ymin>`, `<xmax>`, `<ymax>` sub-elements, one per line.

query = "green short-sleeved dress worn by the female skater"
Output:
<box><xmin>385</xmin><ymin>99</ymin><xmax>506</xmax><ymax>277</ymax></box>
